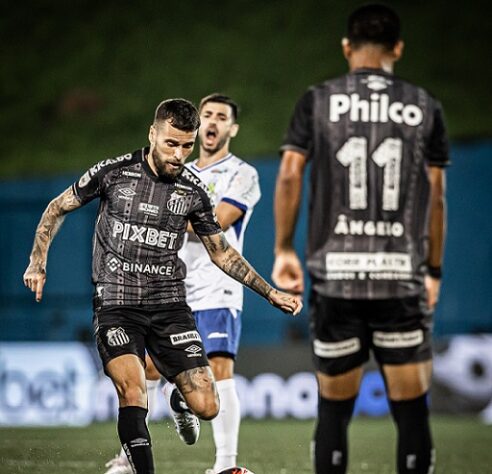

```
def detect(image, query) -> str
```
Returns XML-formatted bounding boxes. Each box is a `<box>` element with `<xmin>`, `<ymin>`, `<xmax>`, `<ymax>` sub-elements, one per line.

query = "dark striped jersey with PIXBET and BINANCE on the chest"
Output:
<box><xmin>73</xmin><ymin>148</ymin><xmax>221</xmax><ymax>306</ymax></box>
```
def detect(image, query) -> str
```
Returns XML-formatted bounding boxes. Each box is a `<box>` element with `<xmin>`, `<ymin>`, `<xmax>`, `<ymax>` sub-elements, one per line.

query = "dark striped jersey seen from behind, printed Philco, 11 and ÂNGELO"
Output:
<box><xmin>281</xmin><ymin>69</ymin><xmax>448</xmax><ymax>299</ymax></box>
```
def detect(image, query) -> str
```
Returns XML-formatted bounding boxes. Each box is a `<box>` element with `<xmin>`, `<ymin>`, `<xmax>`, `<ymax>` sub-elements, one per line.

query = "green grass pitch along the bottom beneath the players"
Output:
<box><xmin>0</xmin><ymin>416</ymin><xmax>492</xmax><ymax>474</ymax></box>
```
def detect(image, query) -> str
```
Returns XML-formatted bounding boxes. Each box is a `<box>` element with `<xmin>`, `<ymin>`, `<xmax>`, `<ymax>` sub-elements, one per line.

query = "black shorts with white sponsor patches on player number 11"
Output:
<box><xmin>309</xmin><ymin>292</ymin><xmax>432</xmax><ymax>375</ymax></box>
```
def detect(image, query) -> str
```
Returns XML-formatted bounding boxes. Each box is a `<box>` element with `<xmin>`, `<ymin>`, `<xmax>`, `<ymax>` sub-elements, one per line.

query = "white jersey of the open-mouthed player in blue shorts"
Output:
<box><xmin>179</xmin><ymin>153</ymin><xmax>261</xmax><ymax>311</ymax></box>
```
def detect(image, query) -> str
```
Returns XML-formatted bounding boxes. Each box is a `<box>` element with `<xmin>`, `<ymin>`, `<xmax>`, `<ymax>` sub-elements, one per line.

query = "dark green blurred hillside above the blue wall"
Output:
<box><xmin>0</xmin><ymin>0</ymin><xmax>492</xmax><ymax>177</ymax></box>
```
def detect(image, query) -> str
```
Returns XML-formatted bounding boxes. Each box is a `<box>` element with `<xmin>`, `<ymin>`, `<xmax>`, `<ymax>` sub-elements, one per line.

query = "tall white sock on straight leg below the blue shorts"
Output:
<box><xmin>212</xmin><ymin>379</ymin><xmax>241</xmax><ymax>472</ymax></box>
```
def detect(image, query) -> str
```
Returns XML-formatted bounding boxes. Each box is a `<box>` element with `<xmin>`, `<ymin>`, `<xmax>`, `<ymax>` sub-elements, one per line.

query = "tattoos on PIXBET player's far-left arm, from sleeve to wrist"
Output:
<box><xmin>31</xmin><ymin>188</ymin><xmax>81</xmax><ymax>271</ymax></box>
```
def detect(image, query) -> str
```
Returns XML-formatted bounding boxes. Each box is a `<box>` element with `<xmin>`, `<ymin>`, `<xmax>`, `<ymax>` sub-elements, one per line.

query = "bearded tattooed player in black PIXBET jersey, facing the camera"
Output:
<box><xmin>24</xmin><ymin>99</ymin><xmax>302</xmax><ymax>474</ymax></box>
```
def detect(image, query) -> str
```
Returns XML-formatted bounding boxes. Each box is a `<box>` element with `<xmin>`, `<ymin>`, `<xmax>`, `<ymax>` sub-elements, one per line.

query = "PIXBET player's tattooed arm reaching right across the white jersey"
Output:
<box><xmin>200</xmin><ymin>232</ymin><xmax>302</xmax><ymax>315</ymax></box>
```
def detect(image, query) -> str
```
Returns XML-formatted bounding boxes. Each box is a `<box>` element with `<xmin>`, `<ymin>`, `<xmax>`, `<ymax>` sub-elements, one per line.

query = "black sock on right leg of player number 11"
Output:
<box><xmin>390</xmin><ymin>394</ymin><xmax>434</xmax><ymax>474</ymax></box>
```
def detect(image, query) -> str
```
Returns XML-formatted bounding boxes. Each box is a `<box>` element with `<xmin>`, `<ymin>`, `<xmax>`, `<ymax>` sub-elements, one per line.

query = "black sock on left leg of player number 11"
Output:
<box><xmin>314</xmin><ymin>397</ymin><xmax>355</xmax><ymax>474</ymax></box>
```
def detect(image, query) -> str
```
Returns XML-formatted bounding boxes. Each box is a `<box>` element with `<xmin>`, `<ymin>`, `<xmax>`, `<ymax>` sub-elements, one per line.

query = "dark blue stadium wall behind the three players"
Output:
<box><xmin>0</xmin><ymin>142</ymin><xmax>492</xmax><ymax>345</ymax></box>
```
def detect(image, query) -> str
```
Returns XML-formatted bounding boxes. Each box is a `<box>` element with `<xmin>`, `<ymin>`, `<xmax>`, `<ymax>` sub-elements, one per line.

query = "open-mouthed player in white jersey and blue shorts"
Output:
<box><xmin>180</xmin><ymin>94</ymin><xmax>261</xmax><ymax>474</ymax></box>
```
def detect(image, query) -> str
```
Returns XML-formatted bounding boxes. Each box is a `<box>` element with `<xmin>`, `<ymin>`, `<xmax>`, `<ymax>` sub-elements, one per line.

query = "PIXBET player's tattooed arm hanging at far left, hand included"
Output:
<box><xmin>24</xmin><ymin>187</ymin><xmax>82</xmax><ymax>302</ymax></box>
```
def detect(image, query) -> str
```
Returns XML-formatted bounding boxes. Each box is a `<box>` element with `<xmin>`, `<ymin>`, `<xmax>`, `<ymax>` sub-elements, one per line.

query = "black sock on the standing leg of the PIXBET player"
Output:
<box><xmin>118</xmin><ymin>407</ymin><xmax>154</xmax><ymax>474</ymax></box>
